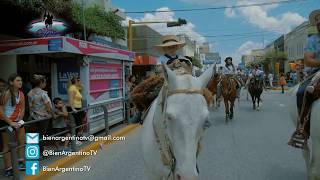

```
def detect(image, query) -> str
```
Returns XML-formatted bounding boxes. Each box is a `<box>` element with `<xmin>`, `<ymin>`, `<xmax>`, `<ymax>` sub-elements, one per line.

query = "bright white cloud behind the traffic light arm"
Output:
<box><xmin>123</xmin><ymin>7</ymin><xmax>206</xmax><ymax>44</ymax></box>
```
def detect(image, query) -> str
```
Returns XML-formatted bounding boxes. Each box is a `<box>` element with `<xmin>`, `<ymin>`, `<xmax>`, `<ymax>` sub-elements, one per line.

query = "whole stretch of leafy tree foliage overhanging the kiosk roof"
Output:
<box><xmin>11</xmin><ymin>0</ymin><xmax>125</xmax><ymax>39</ymax></box>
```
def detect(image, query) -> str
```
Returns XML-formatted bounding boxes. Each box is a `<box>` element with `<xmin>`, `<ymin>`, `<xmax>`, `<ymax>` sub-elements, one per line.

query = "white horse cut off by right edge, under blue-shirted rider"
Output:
<box><xmin>289</xmin><ymin>85</ymin><xmax>320</xmax><ymax>180</ymax></box>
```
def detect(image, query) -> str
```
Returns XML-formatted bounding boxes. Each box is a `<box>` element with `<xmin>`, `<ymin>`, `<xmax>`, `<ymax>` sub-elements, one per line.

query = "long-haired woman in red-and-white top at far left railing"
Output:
<box><xmin>0</xmin><ymin>74</ymin><xmax>26</xmax><ymax>177</ymax></box>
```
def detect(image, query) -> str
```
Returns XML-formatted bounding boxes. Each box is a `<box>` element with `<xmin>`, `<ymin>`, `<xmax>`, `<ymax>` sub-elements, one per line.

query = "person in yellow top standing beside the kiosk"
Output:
<box><xmin>68</xmin><ymin>76</ymin><xmax>86</xmax><ymax>146</ymax></box>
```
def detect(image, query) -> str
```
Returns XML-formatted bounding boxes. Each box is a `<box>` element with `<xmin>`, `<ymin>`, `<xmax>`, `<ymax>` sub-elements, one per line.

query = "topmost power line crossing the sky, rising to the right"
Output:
<box><xmin>125</xmin><ymin>0</ymin><xmax>307</xmax><ymax>14</ymax></box>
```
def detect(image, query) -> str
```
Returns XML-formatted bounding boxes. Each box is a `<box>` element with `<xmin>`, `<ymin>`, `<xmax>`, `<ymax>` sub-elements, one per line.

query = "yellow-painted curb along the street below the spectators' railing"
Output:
<box><xmin>24</xmin><ymin>124</ymin><xmax>140</xmax><ymax>180</ymax></box>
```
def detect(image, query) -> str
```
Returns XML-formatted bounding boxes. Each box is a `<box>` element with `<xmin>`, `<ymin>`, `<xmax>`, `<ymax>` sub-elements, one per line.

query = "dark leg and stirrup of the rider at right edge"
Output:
<box><xmin>288</xmin><ymin>76</ymin><xmax>320</xmax><ymax>149</ymax></box>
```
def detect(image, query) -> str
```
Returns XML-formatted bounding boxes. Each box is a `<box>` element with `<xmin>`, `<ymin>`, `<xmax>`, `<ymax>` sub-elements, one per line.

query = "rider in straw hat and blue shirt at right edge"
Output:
<box><xmin>289</xmin><ymin>9</ymin><xmax>320</xmax><ymax>146</ymax></box>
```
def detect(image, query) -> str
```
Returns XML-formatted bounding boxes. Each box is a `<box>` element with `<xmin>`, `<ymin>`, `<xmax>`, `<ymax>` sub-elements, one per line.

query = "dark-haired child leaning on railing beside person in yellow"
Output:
<box><xmin>52</xmin><ymin>97</ymin><xmax>71</xmax><ymax>151</ymax></box>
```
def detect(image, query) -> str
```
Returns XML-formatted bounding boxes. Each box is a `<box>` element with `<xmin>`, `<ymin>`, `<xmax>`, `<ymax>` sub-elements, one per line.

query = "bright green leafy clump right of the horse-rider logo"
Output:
<box><xmin>72</xmin><ymin>3</ymin><xmax>125</xmax><ymax>39</ymax></box>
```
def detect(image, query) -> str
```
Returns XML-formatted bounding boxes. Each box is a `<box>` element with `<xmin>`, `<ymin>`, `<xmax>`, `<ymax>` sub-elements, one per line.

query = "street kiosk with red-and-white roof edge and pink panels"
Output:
<box><xmin>0</xmin><ymin>37</ymin><xmax>134</xmax><ymax>134</ymax></box>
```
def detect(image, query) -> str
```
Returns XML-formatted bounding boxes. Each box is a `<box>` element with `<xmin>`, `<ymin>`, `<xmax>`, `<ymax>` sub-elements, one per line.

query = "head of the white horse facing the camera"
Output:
<box><xmin>163</xmin><ymin>65</ymin><xmax>214</xmax><ymax>180</ymax></box>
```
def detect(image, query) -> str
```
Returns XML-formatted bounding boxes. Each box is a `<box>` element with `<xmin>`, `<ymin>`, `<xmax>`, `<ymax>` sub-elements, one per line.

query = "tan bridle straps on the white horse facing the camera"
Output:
<box><xmin>153</xmin><ymin>82</ymin><xmax>209</xmax><ymax>179</ymax></box>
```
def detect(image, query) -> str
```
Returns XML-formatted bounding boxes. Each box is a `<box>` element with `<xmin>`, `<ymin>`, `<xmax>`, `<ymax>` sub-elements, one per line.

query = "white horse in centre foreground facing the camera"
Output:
<box><xmin>142</xmin><ymin>65</ymin><xmax>214</xmax><ymax>180</ymax></box>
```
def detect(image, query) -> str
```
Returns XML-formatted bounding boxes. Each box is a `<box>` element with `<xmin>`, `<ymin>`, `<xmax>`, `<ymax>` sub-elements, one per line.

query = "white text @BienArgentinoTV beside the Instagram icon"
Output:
<box><xmin>42</xmin><ymin>150</ymin><xmax>98</xmax><ymax>157</ymax></box>
